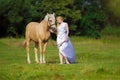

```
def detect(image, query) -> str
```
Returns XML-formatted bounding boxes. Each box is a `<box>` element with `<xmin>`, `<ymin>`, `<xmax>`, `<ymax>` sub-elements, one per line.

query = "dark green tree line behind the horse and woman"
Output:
<box><xmin>0</xmin><ymin>0</ymin><xmax>120</xmax><ymax>38</ymax></box>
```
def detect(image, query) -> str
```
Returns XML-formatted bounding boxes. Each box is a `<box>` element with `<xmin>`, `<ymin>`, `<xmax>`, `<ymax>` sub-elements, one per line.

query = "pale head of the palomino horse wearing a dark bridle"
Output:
<box><xmin>45</xmin><ymin>13</ymin><xmax>57</xmax><ymax>32</ymax></box>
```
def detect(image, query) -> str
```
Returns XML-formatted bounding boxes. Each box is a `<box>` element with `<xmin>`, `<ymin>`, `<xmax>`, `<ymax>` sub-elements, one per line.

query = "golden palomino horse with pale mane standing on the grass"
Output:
<box><xmin>25</xmin><ymin>13</ymin><xmax>56</xmax><ymax>64</ymax></box>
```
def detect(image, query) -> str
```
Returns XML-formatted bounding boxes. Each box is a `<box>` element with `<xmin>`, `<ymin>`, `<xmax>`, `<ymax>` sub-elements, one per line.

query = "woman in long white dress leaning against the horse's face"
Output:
<box><xmin>51</xmin><ymin>16</ymin><xmax>75</xmax><ymax>64</ymax></box>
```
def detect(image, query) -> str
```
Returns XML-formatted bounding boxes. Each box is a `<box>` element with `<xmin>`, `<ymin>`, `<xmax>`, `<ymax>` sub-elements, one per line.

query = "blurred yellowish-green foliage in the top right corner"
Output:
<box><xmin>101</xmin><ymin>0</ymin><xmax>120</xmax><ymax>26</ymax></box>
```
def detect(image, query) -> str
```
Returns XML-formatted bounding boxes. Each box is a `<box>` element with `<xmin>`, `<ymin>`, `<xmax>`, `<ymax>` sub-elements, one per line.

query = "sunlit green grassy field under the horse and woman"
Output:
<box><xmin>0</xmin><ymin>36</ymin><xmax>120</xmax><ymax>80</ymax></box>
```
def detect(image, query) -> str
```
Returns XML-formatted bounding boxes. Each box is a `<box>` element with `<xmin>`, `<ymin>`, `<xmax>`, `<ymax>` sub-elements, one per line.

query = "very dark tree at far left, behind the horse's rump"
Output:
<box><xmin>0</xmin><ymin>0</ymin><xmax>31</xmax><ymax>36</ymax></box>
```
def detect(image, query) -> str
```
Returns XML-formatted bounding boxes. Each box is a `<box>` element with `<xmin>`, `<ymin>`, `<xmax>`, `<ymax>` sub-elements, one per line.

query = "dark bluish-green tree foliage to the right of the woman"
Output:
<box><xmin>74</xmin><ymin>0</ymin><xmax>106</xmax><ymax>38</ymax></box>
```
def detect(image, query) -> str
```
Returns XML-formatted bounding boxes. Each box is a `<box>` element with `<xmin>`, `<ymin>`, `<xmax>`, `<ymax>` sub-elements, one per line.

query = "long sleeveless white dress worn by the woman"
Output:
<box><xmin>57</xmin><ymin>22</ymin><xmax>75</xmax><ymax>63</ymax></box>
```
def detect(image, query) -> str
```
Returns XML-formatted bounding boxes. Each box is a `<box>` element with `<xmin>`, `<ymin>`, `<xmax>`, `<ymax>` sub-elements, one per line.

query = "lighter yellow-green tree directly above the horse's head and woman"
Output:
<box><xmin>33</xmin><ymin>0</ymin><xmax>81</xmax><ymax>34</ymax></box>
